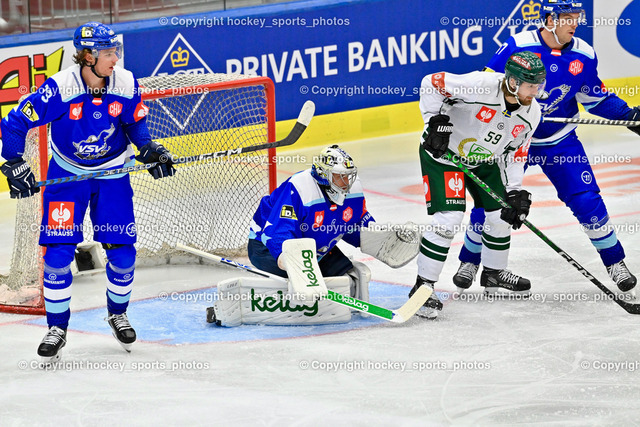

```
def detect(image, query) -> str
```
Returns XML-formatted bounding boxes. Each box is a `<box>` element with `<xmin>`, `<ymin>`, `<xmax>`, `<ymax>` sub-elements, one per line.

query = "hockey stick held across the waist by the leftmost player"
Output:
<box><xmin>36</xmin><ymin>101</ymin><xmax>316</xmax><ymax>187</ymax></box>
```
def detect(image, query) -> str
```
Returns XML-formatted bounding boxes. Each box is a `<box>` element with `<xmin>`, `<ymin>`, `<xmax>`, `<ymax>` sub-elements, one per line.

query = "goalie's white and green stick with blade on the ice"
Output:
<box><xmin>176</xmin><ymin>243</ymin><xmax>433</xmax><ymax>323</ymax></box>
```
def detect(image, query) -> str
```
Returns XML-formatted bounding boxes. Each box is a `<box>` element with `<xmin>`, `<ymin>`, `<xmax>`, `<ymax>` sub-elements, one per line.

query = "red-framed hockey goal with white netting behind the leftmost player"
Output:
<box><xmin>0</xmin><ymin>74</ymin><xmax>276</xmax><ymax>313</ymax></box>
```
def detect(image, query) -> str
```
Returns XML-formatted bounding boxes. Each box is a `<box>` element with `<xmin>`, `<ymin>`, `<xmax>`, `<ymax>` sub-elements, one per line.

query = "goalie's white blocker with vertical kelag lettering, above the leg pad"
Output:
<box><xmin>279</xmin><ymin>238</ymin><xmax>327</xmax><ymax>300</ymax></box>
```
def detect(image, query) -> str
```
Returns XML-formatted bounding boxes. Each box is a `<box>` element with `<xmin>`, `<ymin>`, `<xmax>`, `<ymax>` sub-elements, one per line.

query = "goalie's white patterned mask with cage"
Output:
<box><xmin>311</xmin><ymin>145</ymin><xmax>358</xmax><ymax>205</ymax></box>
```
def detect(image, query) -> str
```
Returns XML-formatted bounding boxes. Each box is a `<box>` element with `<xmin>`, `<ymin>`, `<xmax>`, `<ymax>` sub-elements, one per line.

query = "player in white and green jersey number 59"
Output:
<box><xmin>410</xmin><ymin>52</ymin><xmax>546</xmax><ymax>318</ymax></box>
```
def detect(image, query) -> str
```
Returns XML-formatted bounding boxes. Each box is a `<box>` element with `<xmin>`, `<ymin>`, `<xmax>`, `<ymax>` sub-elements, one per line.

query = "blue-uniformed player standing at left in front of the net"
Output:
<box><xmin>0</xmin><ymin>22</ymin><xmax>174</xmax><ymax>360</ymax></box>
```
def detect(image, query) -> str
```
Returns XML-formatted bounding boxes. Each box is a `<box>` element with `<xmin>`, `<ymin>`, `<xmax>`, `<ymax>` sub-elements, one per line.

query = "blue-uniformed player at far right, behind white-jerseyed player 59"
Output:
<box><xmin>453</xmin><ymin>0</ymin><xmax>640</xmax><ymax>292</ymax></box>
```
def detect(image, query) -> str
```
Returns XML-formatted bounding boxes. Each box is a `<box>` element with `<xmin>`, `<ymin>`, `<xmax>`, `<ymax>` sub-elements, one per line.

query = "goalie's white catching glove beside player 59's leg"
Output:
<box><xmin>360</xmin><ymin>222</ymin><xmax>421</xmax><ymax>268</ymax></box>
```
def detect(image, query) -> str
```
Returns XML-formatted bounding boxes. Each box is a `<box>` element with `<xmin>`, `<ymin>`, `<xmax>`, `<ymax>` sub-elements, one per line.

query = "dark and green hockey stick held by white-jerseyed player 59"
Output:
<box><xmin>443</xmin><ymin>151</ymin><xmax>640</xmax><ymax>314</ymax></box>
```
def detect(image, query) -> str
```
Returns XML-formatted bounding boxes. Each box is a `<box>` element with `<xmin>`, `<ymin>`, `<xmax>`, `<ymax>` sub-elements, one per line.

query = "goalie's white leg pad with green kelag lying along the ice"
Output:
<box><xmin>213</xmin><ymin>276</ymin><xmax>351</xmax><ymax>326</ymax></box>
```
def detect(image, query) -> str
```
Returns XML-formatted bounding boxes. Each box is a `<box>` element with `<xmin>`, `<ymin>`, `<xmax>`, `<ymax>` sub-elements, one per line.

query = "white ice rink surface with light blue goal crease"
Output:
<box><xmin>0</xmin><ymin>126</ymin><xmax>640</xmax><ymax>426</ymax></box>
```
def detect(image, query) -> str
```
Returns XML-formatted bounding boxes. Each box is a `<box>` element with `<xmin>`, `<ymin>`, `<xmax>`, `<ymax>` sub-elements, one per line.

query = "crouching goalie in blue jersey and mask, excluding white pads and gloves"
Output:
<box><xmin>249</xmin><ymin>145</ymin><xmax>374</xmax><ymax>277</ymax></box>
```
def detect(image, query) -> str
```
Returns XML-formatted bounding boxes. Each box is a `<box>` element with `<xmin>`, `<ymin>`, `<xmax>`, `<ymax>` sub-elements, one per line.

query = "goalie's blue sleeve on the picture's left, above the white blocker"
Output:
<box><xmin>262</xmin><ymin>182</ymin><xmax>306</xmax><ymax>260</ymax></box>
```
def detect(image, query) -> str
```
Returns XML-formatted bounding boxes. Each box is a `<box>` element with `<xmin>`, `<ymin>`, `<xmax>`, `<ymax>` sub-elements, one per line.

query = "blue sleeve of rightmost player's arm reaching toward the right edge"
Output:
<box><xmin>576</xmin><ymin>57</ymin><xmax>632</xmax><ymax>120</ymax></box>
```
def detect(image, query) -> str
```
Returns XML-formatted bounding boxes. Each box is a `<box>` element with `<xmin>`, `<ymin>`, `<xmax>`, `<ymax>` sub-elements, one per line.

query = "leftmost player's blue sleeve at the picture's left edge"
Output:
<box><xmin>0</xmin><ymin>79</ymin><xmax>63</xmax><ymax>160</ymax></box>
